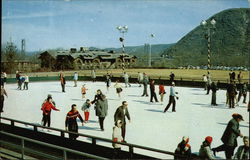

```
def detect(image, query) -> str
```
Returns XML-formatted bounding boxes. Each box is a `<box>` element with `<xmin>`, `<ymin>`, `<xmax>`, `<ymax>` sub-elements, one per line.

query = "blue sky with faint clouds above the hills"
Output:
<box><xmin>2</xmin><ymin>0</ymin><xmax>250</xmax><ymax>51</ymax></box>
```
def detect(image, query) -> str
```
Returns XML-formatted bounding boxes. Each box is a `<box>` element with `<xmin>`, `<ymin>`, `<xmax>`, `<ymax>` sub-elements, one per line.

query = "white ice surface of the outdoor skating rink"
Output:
<box><xmin>2</xmin><ymin>81</ymin><xmax>249</xmax><ymax>159</ymax></box>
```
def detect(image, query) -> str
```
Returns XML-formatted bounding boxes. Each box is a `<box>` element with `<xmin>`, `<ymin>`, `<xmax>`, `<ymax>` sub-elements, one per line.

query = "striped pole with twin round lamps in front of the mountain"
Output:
<box><xmin>201</xmin><ymin>19</ymin><xmax>216</xmax><ymax>70</ymax></box>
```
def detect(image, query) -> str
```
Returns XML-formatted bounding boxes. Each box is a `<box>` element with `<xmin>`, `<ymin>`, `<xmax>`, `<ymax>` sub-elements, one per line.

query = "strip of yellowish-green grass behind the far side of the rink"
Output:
<box><xmin>8</xmin><ymin>69</ymin><xmax>250</xmax><ymax>82</ymax></box>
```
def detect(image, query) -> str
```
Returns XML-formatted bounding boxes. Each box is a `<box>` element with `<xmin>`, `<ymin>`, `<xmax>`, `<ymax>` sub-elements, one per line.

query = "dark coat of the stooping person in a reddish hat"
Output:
<box><xmin>221</xmin><ymin>118</ymin><xmax>240</xmax><ymax>147</ymax></box>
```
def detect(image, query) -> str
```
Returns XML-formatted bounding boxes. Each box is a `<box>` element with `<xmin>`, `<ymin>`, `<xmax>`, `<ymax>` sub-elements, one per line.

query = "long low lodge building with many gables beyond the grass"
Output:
<box><xmin>39</xmin><ymin>47</ymin><xmax>137</xmax><ymax>70</ymax></box>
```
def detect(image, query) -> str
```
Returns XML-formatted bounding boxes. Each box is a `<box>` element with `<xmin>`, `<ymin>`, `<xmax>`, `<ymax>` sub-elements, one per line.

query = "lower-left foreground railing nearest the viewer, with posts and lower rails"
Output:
<box><xmin>0</xmin><ymin>131</ymin><xmax>107</xmax><ymax>160</ymax></box>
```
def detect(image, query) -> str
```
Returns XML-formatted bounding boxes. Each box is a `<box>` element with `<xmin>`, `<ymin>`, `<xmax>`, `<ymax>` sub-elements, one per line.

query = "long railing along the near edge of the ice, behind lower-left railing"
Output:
<box><xmin>0</xmin><ymin>117</ymin><xmax>188</xmax><ymax>158</ymax></box>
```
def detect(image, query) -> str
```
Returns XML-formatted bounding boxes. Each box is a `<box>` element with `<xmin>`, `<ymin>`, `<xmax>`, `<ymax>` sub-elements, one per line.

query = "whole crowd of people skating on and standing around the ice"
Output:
<box><xmin>1</xmin><ymin>70</ymin><xmax>249</xmax><ymax>159</ymax></box>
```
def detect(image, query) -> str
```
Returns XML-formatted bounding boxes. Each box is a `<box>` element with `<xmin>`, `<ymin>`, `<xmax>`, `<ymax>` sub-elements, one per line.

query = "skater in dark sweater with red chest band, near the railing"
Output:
<box><xmin>65</xmin><ymin>104</ymin><xmax>83</xmax><ymax>140</ymax></box>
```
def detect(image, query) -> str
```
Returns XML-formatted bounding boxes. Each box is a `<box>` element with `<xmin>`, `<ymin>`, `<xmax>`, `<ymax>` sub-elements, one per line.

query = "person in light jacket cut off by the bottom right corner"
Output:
<box><xmin>234</xmin><ymin>136</ymin><xmax>250</xmax><ymax>160</ymax></box>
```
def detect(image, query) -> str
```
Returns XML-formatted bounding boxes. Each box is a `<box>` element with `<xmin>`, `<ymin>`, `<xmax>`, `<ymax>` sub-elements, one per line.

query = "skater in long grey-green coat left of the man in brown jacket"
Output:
<box><xmin>95</xmin><ymin>95</ymin><xmax>108</xmax><ymax>131</ymax></box>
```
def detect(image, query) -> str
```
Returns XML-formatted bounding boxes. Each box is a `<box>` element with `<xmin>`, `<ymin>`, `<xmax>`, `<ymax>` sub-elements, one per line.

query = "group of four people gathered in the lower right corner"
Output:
<box><xmin>174</xmin><ymin>113</ymin><xmax>250</xmax><ymax>160</ymax></box>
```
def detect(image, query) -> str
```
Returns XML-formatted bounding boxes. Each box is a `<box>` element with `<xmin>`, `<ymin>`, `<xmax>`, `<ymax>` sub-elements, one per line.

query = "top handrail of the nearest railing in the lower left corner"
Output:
<box><xmin>0</xmin><ymin>131</ymin><xmax>107</xmax><ymax>160</ymax></box>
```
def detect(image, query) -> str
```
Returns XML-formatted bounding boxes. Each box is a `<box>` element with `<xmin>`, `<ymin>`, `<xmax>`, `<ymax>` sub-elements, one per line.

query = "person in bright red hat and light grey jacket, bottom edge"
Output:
<box><xmin>199</xmin><ymin>136</ymin><xmax>215</xmax><ymax>160</ymax></box>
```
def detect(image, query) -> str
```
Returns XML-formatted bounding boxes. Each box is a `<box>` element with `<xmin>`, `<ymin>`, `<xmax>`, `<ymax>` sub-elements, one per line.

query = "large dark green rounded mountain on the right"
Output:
<box><xmin>162</xmin><ymin>8</ymin><xmax>250</xmax><ymax>66</ymax></box>
